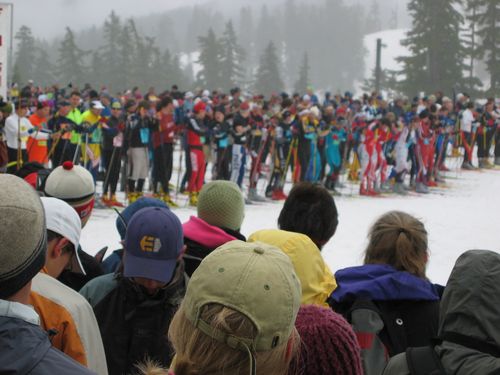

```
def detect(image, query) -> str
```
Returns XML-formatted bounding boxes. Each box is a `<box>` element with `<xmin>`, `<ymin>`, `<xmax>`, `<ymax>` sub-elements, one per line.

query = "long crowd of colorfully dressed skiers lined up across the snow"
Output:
<box><xmin>0</xmin><ymin>85</ymin><xmax>500</xmax><ymax>207</ymax></box>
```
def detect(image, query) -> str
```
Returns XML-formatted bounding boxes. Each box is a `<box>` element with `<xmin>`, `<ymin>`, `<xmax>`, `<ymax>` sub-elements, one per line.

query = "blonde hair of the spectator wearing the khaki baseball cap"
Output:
<box><xmin>168</xmin><ymin>304</ymin><xmax>300</xmax><ymax>375</ymax></box>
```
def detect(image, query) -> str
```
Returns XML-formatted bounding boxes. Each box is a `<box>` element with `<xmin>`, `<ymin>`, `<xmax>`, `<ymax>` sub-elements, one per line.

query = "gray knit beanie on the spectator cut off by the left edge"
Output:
<box><xmin>0</xmin><ymin>174</ymin><xmax>47</xmax><ymax>299</ymax></box>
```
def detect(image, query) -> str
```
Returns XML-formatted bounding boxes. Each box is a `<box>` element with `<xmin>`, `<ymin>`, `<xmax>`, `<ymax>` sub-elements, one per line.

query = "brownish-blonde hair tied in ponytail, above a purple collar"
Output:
<box><xmin>365</xmin><ymin>211</ymin><xmax>428</xmax><ymax>278</ymax></box>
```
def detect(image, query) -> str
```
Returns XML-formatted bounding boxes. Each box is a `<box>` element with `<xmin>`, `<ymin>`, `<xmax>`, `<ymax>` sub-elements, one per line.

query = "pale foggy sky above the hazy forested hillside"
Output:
<box><xmin>4</xmin><ymin>0</ymin><xmax>408</xmax><ymax>40</ymax></box>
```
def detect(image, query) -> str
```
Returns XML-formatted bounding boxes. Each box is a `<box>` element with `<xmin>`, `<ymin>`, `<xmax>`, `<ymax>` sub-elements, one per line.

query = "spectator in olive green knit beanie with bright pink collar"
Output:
<box><xmin>182</xmin><ymin>180</ymin><xmax>245</xmax><ymax>277</ymax></box>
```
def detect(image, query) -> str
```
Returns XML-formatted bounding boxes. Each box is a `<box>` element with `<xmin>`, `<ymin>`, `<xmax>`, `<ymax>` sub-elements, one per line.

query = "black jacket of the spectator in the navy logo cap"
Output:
<box><xmin>80</xmin><ymin>262</ymin><xmax>186</xmax><ymax>375</ymax></box>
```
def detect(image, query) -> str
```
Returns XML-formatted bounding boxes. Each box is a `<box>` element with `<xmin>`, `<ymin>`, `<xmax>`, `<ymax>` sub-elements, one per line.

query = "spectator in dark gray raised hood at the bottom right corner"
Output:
<box><xmin>383</xmin><ymin>250</ymin><xmax>500</xmax><ymax>375</ymax></box>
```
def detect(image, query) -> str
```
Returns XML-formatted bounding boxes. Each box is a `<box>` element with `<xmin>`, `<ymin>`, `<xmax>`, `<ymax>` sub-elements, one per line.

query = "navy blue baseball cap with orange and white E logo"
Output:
<box><xmin>123</xmin><ymin>207</ymin><xmax>184</xmax><ymax>283</ymax></box>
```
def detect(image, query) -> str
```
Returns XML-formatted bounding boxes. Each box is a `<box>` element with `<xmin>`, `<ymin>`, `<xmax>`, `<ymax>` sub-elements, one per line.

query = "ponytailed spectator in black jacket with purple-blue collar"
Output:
<box><xmin>330</xmin><ymin>211</ymin><xmax>442</xmax><ymax>375</ymax></box>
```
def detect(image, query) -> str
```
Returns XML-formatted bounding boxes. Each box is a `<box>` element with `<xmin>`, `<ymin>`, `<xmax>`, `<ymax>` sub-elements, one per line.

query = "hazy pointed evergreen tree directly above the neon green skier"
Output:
<box><xmin>57</xmin><ymin>27</ymin><xmax>85</xmax><ymax>86</ymax></box>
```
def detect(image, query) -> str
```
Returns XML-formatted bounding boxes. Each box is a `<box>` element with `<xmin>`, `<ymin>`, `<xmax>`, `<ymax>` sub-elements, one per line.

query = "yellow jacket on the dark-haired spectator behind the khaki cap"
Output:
<box><xmin>248</xmin><ymin>229</ymin><xmax>337</xmax><ymax>306</ymax></box>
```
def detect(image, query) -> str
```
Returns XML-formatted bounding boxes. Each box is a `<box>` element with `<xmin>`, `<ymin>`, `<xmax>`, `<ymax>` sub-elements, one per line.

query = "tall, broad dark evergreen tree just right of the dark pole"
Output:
<box><xmin>398</xmin><ymin>0</ymin><xmax>464</xmax><ymax>96</ymax></box>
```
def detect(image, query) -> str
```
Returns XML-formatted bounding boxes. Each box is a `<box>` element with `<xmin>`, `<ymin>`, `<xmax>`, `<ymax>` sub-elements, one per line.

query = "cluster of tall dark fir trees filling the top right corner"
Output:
<box><xmin>391</xmin><ymin>0</ymin><xmax>500</xmax><ymax>96</ymax></box>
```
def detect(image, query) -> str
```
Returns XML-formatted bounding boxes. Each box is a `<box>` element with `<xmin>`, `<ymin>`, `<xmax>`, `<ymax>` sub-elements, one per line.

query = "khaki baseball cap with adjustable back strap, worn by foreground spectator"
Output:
<box><xmin>183</xmin><ymin>241</ymin><xmax>301</xmax><ymax>373</ymax></box>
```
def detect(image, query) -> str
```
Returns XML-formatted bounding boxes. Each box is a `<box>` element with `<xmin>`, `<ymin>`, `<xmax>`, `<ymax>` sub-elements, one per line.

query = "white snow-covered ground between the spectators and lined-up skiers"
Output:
<box><xmin>82</xmin><ymin>159</ymin><xmax>500</xmax><ymax>283</ymax></box>
